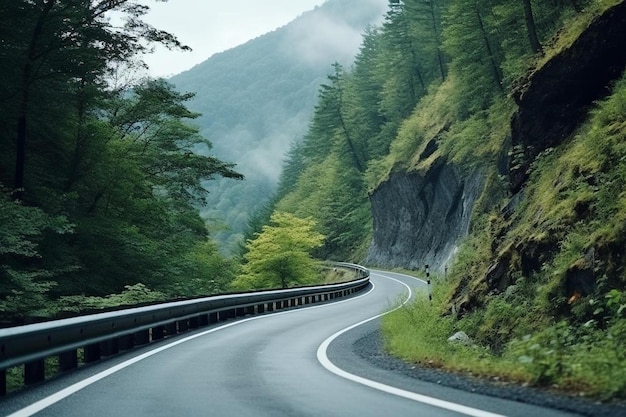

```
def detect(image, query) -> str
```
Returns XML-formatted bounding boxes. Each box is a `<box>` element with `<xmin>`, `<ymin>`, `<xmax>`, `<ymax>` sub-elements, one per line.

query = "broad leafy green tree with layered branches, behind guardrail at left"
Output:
<box><xmin>57</xmin><ymin>80</ymin><xmax>242</xmax><ymax>296</ymax></box>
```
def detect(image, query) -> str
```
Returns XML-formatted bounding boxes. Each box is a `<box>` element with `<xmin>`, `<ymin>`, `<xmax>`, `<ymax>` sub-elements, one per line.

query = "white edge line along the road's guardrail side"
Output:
<box><xmin>6</xmin><ymin>283</ymin><xmax>374</xmax><ymax>417</ymax></box>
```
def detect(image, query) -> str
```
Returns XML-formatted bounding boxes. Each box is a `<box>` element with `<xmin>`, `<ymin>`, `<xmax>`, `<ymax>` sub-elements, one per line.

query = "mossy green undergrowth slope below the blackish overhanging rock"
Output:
<box><xmin>383</xmin><ymin>60</ymin><xmax>626</xmax><ymax>400</ymax></box>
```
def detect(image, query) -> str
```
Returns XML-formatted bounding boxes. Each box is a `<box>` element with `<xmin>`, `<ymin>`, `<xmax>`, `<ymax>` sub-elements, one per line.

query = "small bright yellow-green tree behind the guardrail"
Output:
<box><xmin>233</xmin><ymin>212</ymin><xmax>324</xmax><ymax>290</ymax></box>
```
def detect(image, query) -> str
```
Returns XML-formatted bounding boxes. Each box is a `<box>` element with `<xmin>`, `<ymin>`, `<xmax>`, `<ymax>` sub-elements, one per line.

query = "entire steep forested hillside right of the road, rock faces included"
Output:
<box><xmin>256</xmin><ymin>0</ymin><xmax>626</xmax><ymax>398</ymax></box>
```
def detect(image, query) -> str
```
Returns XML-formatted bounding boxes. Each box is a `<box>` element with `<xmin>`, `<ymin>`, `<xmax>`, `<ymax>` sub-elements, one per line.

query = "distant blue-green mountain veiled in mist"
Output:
<box><xmin>170</xmin><ymin>0</ymin><xmax>387</xmax><ymax>253</ymax></box>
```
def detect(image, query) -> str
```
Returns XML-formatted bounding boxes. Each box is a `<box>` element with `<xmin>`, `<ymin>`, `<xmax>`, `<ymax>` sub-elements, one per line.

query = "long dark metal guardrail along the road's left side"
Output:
<box><xmin>0</xmin><ymin>263</ymin><xmax>369</xmax><ymax>396</ymax></box>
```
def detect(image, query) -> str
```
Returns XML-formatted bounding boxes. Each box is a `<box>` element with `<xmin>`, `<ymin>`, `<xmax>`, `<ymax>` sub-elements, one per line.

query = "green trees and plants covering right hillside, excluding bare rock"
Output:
<box><xmin>264</xmin><ymin>0</ymin><xmax>626</xmax><ymax>396</ymax></box>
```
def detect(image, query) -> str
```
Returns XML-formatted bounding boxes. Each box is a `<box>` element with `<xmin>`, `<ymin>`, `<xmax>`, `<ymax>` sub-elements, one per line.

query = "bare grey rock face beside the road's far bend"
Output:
<box><xmin>366</xmin><ymin>159</ymin><xmax>484</xmax><ymax>272</ymax></box>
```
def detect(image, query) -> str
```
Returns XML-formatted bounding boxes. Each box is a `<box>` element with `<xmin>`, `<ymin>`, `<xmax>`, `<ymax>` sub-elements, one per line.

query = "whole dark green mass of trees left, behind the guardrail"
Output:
<box><xmin>0</xmin><ymin>0</ymin><xmax>242</xmax><ymax>321</ymax></box>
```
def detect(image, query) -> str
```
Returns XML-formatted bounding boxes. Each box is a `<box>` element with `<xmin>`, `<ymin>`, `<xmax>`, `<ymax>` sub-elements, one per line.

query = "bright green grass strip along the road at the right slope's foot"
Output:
<box><xmin>383</xmin><ymin>281</ymin><xmax>626</xmax><ymax>400</ymax></box>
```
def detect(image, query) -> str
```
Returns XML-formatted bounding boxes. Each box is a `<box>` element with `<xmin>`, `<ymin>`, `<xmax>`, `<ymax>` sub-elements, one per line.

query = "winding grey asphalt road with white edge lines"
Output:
<box><xmin>0</xmin><ymin>271</ymin><xmax>571</xmax><ymax>417</ymax></box>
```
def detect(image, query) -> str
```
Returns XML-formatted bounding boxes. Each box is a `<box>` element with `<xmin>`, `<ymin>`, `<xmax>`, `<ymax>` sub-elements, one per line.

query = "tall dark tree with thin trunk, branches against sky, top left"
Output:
<box><xmin>0</xmin><ymin>0</ymin><xmax>189</xmax><ymax>197</ymax></box>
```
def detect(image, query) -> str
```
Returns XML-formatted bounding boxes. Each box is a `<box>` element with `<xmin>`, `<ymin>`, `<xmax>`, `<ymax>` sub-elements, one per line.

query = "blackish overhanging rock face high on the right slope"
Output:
<box><xmin>509</xmin><ymin>2</ymin><xmax>626</xmax><ymax>193</ymax></box>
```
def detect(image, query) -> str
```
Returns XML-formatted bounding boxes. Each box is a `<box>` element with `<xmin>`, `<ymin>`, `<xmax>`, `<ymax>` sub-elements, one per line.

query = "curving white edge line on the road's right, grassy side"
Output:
<box><xmin>317</xmin><ymin>274</ymin><xmax>504</xmax><ymax>417</ymax></box>
